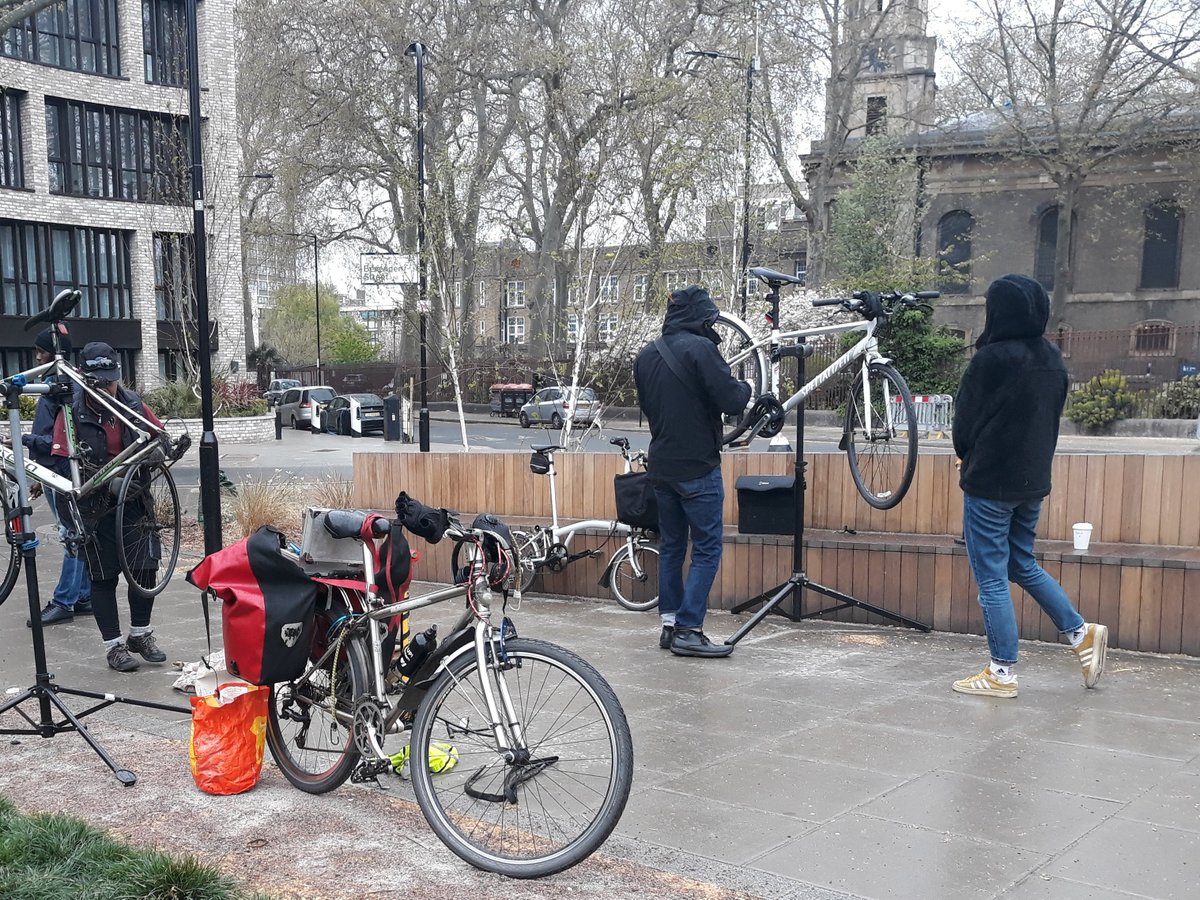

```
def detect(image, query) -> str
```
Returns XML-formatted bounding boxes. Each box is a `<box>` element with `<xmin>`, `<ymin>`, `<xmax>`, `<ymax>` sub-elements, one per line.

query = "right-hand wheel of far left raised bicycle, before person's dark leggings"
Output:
<box><xmin>116</xmin><ymin>462</ymin><xmax>180</xmax><ymax>596</ymax></box>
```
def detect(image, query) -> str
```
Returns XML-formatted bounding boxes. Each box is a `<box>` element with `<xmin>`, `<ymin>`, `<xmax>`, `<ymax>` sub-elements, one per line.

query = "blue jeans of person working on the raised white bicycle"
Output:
<box><xmin>654</xmin><ymin>466</ymin><xmax>725</xmax><ymax>629</ymax></box>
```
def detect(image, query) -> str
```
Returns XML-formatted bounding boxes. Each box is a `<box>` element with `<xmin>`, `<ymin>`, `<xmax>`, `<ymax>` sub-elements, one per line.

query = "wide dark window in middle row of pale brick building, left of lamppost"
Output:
<box><xmin>46</xmin><ymin>97</ymin><xmax>191</xmax><ymax>205</ymax></box>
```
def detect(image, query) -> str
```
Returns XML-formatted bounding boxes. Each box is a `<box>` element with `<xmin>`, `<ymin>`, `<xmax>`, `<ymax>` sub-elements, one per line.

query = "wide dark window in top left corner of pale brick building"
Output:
<box><xmin>0</xmin><ymin>0</ymin><xmax>121</xmax><ymax>78</ymax></box>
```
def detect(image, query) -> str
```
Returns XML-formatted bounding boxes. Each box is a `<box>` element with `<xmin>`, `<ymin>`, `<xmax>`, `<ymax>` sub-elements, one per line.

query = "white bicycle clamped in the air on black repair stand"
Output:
<box><xmin>714</xmin><ymin>268</ymin><xmax>940</xmax><ymax>509</ymax></box>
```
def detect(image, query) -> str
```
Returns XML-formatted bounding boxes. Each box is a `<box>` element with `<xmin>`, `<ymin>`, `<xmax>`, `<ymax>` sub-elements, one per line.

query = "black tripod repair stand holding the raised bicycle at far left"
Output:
<box><xmin>0</xmin><ymin>376</ymin><xmax>192</xmax><ymax>787</ymax></box>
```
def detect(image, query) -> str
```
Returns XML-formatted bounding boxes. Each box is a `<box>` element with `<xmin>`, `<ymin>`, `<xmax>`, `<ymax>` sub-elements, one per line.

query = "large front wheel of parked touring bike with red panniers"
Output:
<box><xmin>412</xmin><ymin>638</ymin><xmax>634</xmax><ymax>878</ymax></box>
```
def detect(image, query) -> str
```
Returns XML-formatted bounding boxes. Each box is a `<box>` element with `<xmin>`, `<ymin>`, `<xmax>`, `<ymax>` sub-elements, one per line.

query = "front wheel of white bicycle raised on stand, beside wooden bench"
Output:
<box><xmin>842</xmin><ymin>362</ymin><xmax>917</xmax><ymax>509</ymax></box>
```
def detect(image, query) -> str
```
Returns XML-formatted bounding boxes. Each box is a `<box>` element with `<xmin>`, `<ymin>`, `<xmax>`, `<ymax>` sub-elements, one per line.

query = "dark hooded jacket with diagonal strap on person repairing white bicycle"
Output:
<box><xmin>634</xmin><ymin>286</ymin><xmax>750</xmax><ymax>481</ymax></box>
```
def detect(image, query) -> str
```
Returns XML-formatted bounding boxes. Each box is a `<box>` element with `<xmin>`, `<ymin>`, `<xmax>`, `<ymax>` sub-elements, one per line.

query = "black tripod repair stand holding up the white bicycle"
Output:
<box><xmin>725</xmin><ymin>276</ymin><xmax>931</xmax><ymax>644</ymax></box>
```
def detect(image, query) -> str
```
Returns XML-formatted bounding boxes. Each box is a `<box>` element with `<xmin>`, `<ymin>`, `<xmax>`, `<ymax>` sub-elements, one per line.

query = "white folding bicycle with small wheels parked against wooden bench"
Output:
<box><xmin>512</xmin><ymin>438</ymin><xmax>659</xmax><ymax>612</ymax></box>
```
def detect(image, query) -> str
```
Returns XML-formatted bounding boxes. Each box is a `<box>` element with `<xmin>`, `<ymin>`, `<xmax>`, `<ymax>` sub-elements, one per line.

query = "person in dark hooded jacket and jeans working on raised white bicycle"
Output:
<box><xmin>634</xmin><ymin>286</ymin><xmax>750</xmax><ymax>656</ymax></box>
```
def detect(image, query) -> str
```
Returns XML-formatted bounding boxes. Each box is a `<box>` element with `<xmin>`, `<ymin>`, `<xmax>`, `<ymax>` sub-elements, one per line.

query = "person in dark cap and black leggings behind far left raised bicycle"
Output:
<box><xmin>52</xmin><ymin>341</ymin><xmax>167</xmax><ymax>672</ymax></box>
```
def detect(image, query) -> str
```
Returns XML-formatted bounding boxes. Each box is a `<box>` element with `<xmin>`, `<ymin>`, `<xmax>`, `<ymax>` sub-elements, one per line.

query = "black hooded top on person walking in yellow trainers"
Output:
<box><xmin>953</xmin><ymin>275</ymin><xmax>1067</xmax><ymax>500</ymax></box>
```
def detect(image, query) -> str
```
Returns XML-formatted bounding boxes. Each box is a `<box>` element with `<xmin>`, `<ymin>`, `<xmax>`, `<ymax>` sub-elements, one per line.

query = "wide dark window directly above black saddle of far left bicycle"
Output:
<box><xmin>0</xmin><ymin>218</ymin><xmax>133</xmax><ymax>319</ymax></box>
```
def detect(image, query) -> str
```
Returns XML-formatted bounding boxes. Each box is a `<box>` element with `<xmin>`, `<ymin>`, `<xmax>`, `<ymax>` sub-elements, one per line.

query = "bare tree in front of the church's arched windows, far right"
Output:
<box><xmin>954</xmin><ymin>0</ymin><xmax>1200</xmax><ymax>326</ymax></box>
